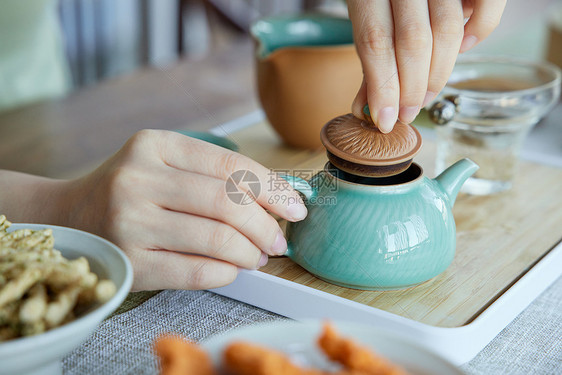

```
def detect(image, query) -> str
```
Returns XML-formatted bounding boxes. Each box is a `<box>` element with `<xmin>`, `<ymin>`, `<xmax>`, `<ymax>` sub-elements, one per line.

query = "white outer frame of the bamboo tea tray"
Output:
<box><xmin>206</xmin><ymin>111</ymin><xmax>562</xmax><ymax>365</ymax></box>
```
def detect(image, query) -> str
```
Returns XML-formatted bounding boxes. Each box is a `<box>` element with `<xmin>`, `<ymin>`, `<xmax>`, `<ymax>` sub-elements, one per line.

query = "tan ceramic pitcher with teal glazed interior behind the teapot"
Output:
<box><xmin>251</xmin><ymin>15</ymin><xmax>363</xmax><ymax>149</ymax></box>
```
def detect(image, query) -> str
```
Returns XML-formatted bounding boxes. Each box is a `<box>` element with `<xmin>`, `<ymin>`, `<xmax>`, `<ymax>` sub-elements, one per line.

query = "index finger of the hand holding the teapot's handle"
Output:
<box><xmin>160</xmin><ymin>132</ymin><xmax>307</xmax><ymax>221</ymax></box>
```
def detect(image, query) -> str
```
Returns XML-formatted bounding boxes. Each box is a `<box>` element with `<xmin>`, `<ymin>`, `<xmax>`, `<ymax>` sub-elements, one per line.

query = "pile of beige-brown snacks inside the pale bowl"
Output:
<box><xmin>0</xmin><ymin>215</ymin><xmax>116</xmax><ymax>341</ymax></box>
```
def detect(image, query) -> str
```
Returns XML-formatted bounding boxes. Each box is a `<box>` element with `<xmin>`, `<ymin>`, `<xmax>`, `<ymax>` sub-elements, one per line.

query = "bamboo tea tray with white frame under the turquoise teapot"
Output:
<box><xmin>210</xmin><ymin>113</ymin><xmax>562</xmax><ymax>364</ymax></box>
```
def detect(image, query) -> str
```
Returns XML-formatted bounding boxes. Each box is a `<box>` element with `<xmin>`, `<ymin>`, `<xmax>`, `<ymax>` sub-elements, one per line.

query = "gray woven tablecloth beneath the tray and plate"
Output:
<box><xmin>63</xmin><ymin>278</ymin><xmax>562</xmax><ymax>375</ymax></box>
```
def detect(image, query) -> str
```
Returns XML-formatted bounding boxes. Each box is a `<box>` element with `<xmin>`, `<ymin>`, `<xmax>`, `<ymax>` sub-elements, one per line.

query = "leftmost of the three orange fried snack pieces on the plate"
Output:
<box><xmin>154</xmin><ymin>336</ymin><xmax>217</xmax><ymax>375</ymax></box>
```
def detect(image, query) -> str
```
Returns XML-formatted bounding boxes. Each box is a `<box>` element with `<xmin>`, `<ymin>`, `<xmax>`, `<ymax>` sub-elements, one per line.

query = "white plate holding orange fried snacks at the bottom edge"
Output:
<box><xmin>202</xmin><ymin>321</ymin><xmax>462</xmax><ymax>375</ymax></box>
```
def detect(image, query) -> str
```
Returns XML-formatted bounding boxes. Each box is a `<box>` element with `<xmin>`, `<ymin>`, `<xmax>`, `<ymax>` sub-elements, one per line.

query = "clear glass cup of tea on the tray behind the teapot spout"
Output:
<box><xmin>428</xmin><ymin>56</ymin><xmax>561</xmax><ymax>195</ymax></box>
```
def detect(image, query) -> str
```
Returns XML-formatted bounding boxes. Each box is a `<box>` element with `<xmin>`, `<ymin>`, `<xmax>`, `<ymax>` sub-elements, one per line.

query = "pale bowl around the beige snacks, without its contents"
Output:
<box><xmin>0</xmin><ymin>224</ymin><xmax>133</xmax><ymax>375</ymax></box>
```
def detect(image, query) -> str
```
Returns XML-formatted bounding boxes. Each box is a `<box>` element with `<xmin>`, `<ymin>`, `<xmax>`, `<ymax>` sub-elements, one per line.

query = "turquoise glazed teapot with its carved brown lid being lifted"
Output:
<box><xmin>284</xmin><ymin>109</ymin><xmax>478</xmax><ymax>290</ymax></box>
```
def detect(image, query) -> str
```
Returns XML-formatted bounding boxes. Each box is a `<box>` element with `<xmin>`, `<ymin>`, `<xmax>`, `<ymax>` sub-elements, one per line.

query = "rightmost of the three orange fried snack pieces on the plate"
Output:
<box><xmin>318</xmin><ymin>323</ymin><xmax>407</xmax><ymax>375</ymax></box>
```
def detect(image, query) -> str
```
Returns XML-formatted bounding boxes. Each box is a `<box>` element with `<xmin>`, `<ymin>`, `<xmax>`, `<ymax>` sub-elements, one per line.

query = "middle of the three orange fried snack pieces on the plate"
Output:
<box><xmin>222</xmin><ymin>342</ymin><xmax>324</xmax><ymax>375</ymax></box>
